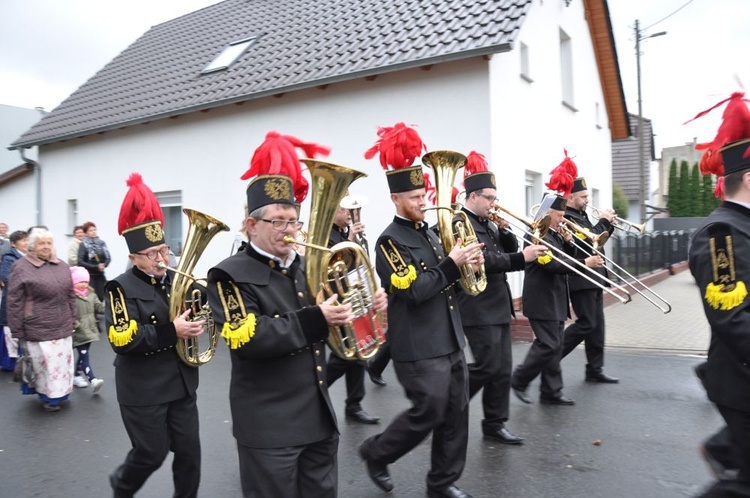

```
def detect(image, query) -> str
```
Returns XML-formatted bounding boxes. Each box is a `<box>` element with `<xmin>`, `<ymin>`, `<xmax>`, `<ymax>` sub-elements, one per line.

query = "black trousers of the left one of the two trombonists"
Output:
<box><xmin>511</xmin><ymin>318</ymin><xmax>565</xmax><ymax>397</ymax></box>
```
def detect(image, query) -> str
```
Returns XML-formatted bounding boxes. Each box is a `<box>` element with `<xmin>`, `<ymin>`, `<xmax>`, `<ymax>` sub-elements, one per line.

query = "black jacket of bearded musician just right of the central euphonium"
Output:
<box><xmin>457</xmin><ymin>209</ymin><xmax>525</xmax><ymax>327</ymax></box>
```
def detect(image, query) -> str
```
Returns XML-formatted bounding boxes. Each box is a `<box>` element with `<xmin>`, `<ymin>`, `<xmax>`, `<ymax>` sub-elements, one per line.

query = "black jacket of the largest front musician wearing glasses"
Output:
<box><xmin>208</xmin><ymin>244</ymin><xmax>337</xmax><ymax>448</ymax></box>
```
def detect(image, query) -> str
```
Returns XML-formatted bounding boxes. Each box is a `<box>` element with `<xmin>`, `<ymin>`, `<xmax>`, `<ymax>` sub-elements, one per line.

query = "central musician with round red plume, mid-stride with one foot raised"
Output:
<box><xmin>359</xmin><ymin>123</ymin><xmax>483</xmax><ymax>498</ymax></box>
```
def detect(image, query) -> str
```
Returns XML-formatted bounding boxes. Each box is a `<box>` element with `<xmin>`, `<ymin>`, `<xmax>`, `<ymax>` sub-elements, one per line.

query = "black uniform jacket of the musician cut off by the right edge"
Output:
<box><xmin>689</xmin><ymin>202</ymin><xmax>750</xmax><ymax>411</ymax></box>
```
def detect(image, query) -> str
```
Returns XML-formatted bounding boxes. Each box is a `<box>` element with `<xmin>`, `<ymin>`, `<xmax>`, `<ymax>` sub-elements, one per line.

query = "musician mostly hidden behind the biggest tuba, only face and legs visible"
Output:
<box><xmin>326</xmin><ymin>202</ymin><xmax>380</xmax><ymax>424</ymax></box>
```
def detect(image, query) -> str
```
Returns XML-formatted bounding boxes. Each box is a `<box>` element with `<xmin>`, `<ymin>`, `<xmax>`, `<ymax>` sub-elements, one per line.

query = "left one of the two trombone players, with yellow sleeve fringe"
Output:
<box><xmin>511</xmin><ymin>194</ymin><xmax>604</xmax><ymax>405</ymax></box>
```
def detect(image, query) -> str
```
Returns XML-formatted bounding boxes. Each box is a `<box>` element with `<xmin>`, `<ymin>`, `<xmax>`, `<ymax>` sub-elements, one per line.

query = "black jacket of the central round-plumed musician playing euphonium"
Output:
<box><xmin>375</xmin><ymin>217</ymin><xmax>464</xmax><ymax>361</ymax></box>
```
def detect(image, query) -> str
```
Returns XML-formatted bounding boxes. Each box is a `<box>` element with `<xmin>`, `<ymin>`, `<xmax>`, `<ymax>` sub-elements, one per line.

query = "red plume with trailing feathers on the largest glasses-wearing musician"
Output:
<box><xmin>240</xmin><ymin>131</ymin><xmax>331</xmax><ymax>202</ymax></box>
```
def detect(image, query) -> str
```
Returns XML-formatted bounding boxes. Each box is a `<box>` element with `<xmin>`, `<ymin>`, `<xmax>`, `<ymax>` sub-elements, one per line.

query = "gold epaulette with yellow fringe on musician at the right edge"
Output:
<box><xmin>704</xmin><ymin>223</ymin><xmax>747</xmax><ymax>311</ymax></box>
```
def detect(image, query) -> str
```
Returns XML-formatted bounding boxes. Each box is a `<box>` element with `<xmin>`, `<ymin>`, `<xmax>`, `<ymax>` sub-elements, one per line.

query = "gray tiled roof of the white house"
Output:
<box><xmin>13</xmin><ymin>0</ymin><xmax>531</xmax><ymax>147</ymax></box>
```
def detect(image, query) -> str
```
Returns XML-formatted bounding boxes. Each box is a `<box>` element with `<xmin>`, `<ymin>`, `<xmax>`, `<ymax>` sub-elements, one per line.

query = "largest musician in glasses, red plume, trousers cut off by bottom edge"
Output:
<box><xmin>208</xmin><ymin>132</ymin><xmax>386</xmax><ymax>498</ymax></box>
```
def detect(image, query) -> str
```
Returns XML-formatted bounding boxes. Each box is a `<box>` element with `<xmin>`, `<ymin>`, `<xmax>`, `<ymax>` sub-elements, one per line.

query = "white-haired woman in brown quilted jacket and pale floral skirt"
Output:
<box><xmin>7</xmin><ymin>228</ymin><xmax>75</xmax><ymax>412</ymax></box>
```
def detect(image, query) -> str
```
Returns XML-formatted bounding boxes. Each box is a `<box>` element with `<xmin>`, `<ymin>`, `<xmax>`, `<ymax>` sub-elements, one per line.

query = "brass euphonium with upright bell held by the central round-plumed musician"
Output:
<box><xmin>422</xmin><ymin>150</ymin><xmax>487</xmax><ymax>296</ymax></box>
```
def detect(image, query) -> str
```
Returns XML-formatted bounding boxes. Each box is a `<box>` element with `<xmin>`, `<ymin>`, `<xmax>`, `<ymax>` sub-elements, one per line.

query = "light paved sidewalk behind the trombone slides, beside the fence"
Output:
<box><xmin>604</xmin><ymin>269</ymin><xmax>711</xmax><ymax>355</ymax></box>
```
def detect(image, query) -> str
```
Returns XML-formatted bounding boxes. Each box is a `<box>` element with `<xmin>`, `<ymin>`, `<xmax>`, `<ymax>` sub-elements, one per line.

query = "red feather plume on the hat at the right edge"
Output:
<box><xmin>684</xmin><ymin>92</ymin><xmax>750</xmax><ymax>178</ymax></box>
